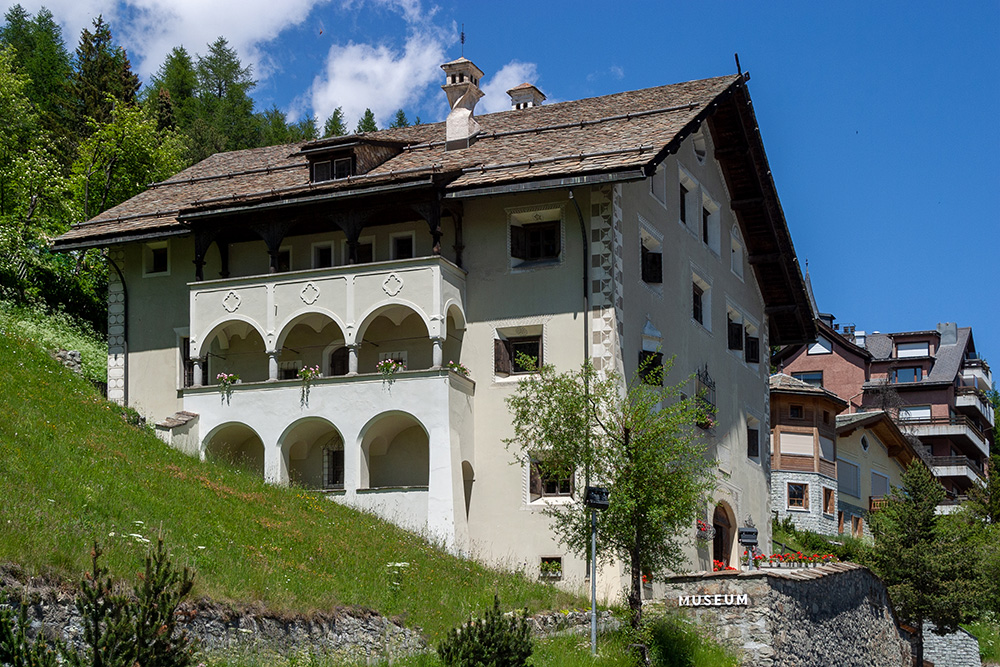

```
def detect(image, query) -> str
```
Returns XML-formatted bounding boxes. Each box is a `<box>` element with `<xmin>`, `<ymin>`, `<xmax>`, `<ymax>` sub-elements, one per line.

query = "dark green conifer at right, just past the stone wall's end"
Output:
<box><xmin>869</xmin><ymin>461</ymin><xmax>981</xmax><ymax>665</ymax></box>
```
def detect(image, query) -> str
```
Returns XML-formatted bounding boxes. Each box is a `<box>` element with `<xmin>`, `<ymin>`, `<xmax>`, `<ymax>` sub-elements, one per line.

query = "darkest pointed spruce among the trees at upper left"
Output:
<box><xmin>73</xmin><ymin>16</ymin><xmax>139</xmax><ymax>135</ymax></box>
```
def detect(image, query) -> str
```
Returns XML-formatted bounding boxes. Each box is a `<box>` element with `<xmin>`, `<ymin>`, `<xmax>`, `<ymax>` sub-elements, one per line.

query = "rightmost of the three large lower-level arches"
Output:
<box><xmin>358</xmin><ymin>411</ymin><xmax>430</xmax><ymax>489</ymax></box>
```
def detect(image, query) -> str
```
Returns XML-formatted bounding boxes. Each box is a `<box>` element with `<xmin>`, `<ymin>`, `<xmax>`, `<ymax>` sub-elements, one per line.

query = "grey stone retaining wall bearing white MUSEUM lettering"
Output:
<box><xmin>664</xmin><ymin>563</ymin><xmax>911</xmax><ymax>667</ymax></box>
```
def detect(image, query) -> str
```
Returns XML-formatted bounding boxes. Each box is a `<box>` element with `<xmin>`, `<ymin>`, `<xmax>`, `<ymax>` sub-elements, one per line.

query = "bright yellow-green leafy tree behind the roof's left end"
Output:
<box><xmin>71</xmin><ymin>97</ymin><xmax>185</xmax><ymax>218</ymax></box>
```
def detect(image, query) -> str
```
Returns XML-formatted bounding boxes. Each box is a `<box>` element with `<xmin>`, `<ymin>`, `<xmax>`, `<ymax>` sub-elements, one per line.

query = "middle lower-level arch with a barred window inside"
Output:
<box><xmin>278</xmin><ymin>417</ymin><xmax>344</xmax><ymax>489</ymax></box>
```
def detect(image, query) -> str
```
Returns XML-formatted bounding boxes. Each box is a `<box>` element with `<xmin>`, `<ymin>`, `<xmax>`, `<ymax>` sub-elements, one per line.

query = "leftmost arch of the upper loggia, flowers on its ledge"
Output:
<box><xmin>198</xmin><ymin>316</ymin><xmax>268</xmax><ymax>384</ymax></box>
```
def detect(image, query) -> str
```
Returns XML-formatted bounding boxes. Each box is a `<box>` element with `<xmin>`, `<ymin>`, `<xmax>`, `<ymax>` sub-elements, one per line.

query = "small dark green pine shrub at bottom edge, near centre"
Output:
<box><xmin>438</xmin><ymin>596</ymin><xmax>532</xmax><ymax>667</ymax></box>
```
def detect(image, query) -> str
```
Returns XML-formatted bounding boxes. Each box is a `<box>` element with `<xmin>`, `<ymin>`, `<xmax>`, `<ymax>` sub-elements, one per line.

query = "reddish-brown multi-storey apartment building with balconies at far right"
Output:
<box><xmin>772</xmin><ymin>315</ymin><xmax>994</xmax><ymax>504</ymax></box>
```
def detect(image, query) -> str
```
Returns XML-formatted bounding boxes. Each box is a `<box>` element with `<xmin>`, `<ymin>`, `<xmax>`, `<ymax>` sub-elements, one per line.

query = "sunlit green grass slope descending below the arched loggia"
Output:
<box><xmin>0</xmin><ymin>326</ymin><xmax>586</xmax><ymax>640</ymax></box>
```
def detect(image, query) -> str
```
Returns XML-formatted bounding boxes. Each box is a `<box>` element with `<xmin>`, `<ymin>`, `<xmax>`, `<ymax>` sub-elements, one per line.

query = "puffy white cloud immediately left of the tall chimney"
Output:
<box><xmin>312</xmin><ymin>31</ymin><xmax>445</xmax><ymax>129</ymax></box>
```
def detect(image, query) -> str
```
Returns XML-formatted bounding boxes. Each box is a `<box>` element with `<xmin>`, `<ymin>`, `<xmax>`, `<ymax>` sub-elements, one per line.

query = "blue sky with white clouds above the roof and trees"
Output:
<box><xmin>7</xmin><ymin>0</ymin><xmax>1000</xmax><ymax>362</ymax></box>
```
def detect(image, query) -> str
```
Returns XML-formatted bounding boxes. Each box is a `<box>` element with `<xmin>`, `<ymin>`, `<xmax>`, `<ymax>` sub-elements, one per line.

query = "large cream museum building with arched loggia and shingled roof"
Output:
<box><xmin>54</xmin><ymin>58</ymin><xmax>815</xmax><ymax>596</ymax></box>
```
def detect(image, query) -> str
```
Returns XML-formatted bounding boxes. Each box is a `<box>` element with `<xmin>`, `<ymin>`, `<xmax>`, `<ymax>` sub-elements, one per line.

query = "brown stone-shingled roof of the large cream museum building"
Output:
<box><xmin>54</xmin><ymin>75</ymin><xmax>741</xmax><ymax>249</ymax></box>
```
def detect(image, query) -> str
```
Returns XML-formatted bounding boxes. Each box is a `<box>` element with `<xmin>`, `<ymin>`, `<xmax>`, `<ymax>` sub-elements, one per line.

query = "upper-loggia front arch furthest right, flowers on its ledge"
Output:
<box><xmin>355</xmin><ymin>304</ymin><xmax>434</xmax><ymax>373</ymax></box>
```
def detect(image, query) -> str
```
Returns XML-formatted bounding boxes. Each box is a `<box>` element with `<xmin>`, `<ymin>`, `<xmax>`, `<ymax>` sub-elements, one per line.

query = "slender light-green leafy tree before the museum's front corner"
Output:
<box><xmin>505</xmin><ymin>361</ymin><xmax>713</xmax><ymax>628</ymax></box>
